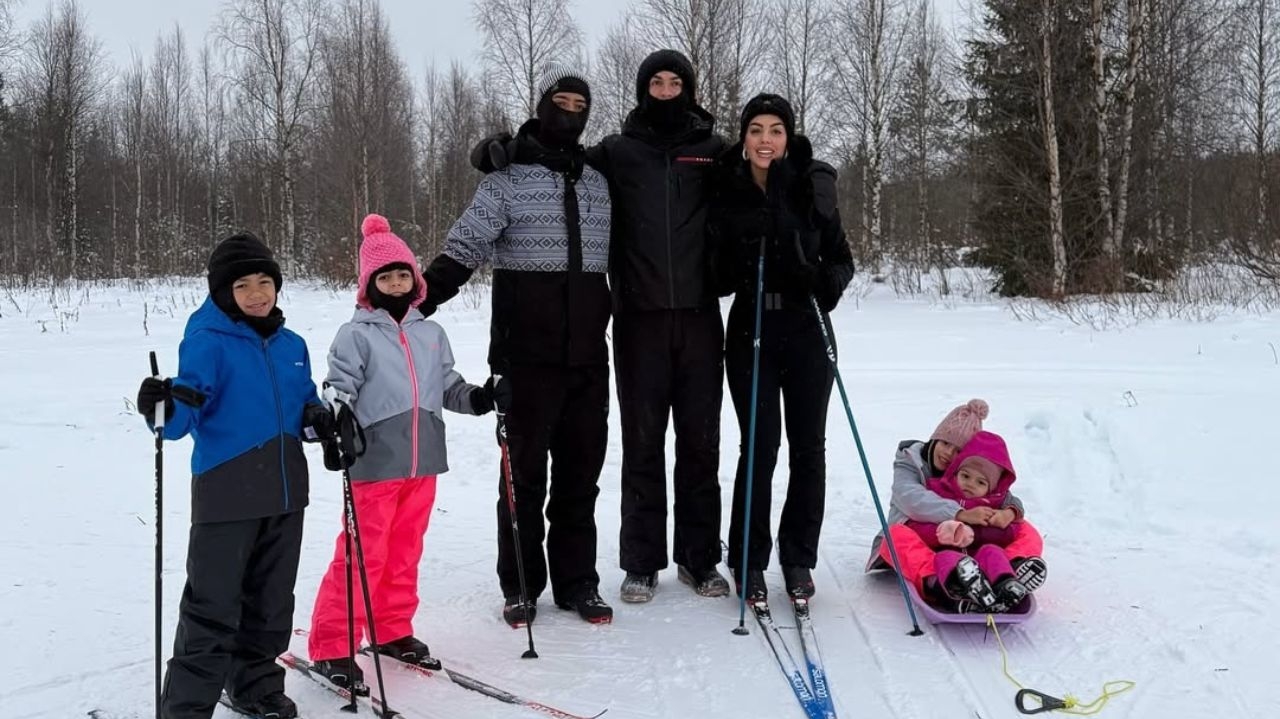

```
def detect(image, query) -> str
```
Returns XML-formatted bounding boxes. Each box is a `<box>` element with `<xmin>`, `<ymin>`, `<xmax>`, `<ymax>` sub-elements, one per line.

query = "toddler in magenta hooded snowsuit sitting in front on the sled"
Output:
<box><xmin>906</xmin><ymin>431</ymin><xmax>1030</xmax><ymax>612</ymax></box>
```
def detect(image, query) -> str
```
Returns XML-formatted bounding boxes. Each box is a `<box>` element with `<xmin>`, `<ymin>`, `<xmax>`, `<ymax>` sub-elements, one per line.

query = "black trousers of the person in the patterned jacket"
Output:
<box><xmin>498</xmin><ymin>365</ymin><xmax>609</xmax><ymax>603</ymax></box>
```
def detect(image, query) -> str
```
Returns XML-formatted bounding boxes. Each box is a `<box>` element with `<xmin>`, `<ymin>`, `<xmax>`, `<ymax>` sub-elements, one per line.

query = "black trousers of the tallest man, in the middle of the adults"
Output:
<box><xmin>613</xmin><ymin>307</ymin><xmax>724</xmax><ymax>574</ymax></box>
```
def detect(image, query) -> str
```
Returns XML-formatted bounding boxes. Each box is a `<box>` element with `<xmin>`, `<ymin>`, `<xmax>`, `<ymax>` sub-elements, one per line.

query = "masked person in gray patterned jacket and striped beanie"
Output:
<box><xmin>422</xmin><ymin>67</ymin><xmax>613</xmax><ymax>627</ymax></box>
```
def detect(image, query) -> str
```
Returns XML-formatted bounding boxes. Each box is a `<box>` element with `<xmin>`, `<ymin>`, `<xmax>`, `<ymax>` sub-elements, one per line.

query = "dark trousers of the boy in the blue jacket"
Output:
<box><xmin>160</xmin><ymin>510</ymin><xmax>302</xmax><ymax>719</ymax></box>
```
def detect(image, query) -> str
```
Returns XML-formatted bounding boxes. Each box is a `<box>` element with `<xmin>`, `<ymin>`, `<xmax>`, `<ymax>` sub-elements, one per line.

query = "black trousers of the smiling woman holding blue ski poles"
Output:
<box><xmin>724</xmin><ymin>299</ymin><xmax>835</xmax><ymax>569</ymax></box>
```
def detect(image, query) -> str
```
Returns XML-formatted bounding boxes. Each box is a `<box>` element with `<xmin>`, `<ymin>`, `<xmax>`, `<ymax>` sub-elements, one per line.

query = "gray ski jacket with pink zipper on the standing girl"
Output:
<box><xmin>325</xmin><ymin>307</ymin><xmax>476</xmax><ymax>481</ymax></box>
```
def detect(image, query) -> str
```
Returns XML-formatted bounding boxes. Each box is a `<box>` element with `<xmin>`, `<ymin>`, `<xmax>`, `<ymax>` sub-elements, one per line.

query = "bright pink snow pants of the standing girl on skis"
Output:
<box><xmin>307</xmin><ymin>475</ymin><xmax>435</xmax><ymax>661</ymax></box>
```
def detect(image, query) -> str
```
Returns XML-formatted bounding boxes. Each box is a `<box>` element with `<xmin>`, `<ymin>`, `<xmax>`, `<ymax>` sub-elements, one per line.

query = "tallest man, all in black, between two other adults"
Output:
<box><xmin>472</xmin><ymin>50</ymin><xmax>728</xmax><ymax>603</ymax></box>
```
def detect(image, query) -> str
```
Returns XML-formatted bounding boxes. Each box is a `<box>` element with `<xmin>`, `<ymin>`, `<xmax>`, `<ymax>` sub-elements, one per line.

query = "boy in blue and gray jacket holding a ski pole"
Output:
<box><xmin>138</xmin><ymin>233</ymin><xmax>334</xmax><ymax>719</ymax></box>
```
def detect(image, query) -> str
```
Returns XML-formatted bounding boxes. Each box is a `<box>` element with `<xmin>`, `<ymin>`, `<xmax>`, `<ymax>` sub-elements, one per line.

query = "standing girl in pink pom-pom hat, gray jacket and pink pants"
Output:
<box><xmin>308</xmin><ymin>215</ymin><xmax>493</xmax><ymax>690</ymax></box>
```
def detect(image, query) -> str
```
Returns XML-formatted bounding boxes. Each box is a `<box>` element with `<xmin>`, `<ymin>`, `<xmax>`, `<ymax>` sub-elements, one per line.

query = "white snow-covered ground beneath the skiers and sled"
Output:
<box><xmin>0</xmin><ymin>280</ymin><xmax>1280</xmax><ymax>719</ymax></box>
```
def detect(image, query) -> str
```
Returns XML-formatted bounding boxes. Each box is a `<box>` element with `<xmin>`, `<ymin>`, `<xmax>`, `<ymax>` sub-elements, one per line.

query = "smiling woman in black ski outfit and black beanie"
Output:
<box><xmin>710</xmin><ymin>95</ymin><xmax>854</xmax><ymax>599</ymax></box>
